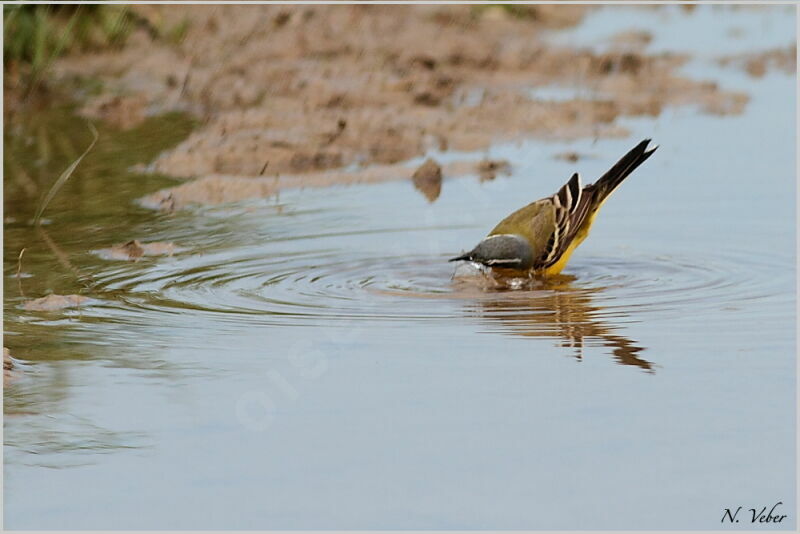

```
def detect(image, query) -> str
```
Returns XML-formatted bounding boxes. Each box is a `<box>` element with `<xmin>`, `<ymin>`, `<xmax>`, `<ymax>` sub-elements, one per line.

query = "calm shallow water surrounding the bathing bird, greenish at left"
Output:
<box><xmin>4</xmin><ymin>6</ymin><xmax>796</xmax><ymax>529</ymax></box>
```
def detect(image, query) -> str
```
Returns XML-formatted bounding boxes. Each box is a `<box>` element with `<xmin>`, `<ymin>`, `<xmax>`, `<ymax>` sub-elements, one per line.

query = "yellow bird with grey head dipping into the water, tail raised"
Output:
<box><xmin>448</xmin><ymin>139</ymin><xmax>658</xmax><ymax>277</ymax></box>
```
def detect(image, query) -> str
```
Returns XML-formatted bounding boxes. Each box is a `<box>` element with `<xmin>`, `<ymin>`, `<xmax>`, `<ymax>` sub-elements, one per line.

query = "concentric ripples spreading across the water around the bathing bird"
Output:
<box><xmin>87</xmin><ymin>238</ymin><xmax>792</xmax><ymax>332</ymax></box>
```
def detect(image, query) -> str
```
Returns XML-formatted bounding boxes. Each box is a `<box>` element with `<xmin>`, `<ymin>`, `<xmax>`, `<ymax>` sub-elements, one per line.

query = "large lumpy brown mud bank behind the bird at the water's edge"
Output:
<box><xmin>50</xmin><ymin>5</ymin><xmax>747</xmax><ymax>206</ymax></box>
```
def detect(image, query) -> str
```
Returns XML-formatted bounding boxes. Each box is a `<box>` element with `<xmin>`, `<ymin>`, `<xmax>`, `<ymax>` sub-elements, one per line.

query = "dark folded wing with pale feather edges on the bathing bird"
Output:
<box><xmin>534</xmin><ymin>173</ymin><xmax>594</xmax><ymax>269</ymax></box>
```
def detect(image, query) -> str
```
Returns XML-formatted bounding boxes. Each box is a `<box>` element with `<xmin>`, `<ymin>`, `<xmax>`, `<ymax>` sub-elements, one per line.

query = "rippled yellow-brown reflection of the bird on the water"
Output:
<box><xmin>453</xmin><ymin>269</ymin><xmax>654</xmax><ymax>373</ymax></box>
